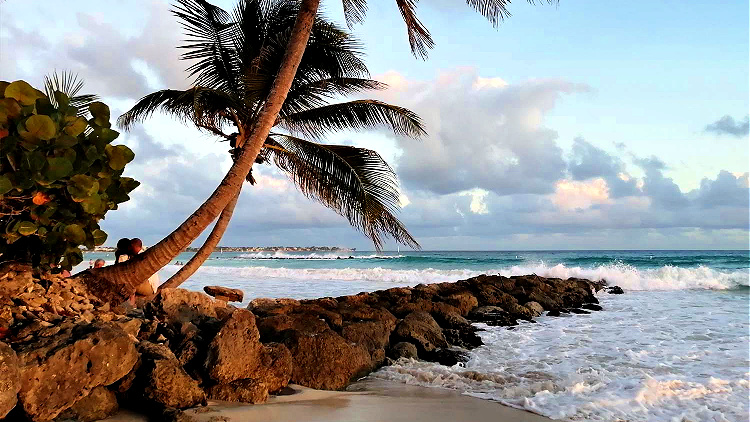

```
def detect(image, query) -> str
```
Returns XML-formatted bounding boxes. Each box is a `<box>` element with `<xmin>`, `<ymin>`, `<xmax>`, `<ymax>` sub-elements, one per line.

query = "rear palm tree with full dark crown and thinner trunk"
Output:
<box><xmin>119</xmin><ymin>0</ymin><xmax>424</xmax><ymax>288</ymax></box>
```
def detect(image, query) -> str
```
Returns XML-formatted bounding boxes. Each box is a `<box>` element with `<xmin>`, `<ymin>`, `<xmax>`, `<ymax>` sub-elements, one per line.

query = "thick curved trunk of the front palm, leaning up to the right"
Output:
<box><xmin>79</xmin><ymin>0</ymin><xmax>320</xmax><ymax>302</ymax></box>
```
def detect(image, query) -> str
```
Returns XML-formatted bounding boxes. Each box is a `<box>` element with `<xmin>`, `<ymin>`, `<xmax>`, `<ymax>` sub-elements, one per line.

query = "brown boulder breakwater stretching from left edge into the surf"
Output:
<box><xmin>0</xmin><ymin>264</ymin><xmax>621</xmax><ymax>422</ymax></box>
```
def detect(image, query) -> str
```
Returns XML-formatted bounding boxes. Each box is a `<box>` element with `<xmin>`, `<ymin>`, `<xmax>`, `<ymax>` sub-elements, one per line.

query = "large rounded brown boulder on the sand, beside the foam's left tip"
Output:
<box><xmin>284</xmin><ymin>330</ymin><xmax>372</xmax><ymax>390</ymax></box>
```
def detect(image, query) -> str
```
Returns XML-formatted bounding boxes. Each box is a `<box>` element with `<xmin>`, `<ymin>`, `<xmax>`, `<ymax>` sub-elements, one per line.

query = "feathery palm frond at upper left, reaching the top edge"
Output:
<box><xmin>172</xmin><ymin>0</ymin><xmax>239</xmax><ymax>93</ymax></box>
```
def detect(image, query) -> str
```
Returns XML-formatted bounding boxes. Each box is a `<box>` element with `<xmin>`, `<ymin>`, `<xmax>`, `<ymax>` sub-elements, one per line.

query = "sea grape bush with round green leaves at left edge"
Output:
<box><xmin>0</xmin><ymin>81</ymin><xmax>139</xmax><ymax>270</ymax></box>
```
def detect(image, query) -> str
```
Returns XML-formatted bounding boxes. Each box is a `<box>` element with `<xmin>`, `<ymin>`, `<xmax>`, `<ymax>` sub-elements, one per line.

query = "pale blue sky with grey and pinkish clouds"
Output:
<box><xmin>0</xmin><ymin>0</ymin><xmax>750</xmax><ymax>250</ymax></box>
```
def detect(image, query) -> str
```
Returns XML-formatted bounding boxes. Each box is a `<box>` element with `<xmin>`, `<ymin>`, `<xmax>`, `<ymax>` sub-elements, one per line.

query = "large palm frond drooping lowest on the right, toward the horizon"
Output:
<box><xmin>265</xmin><ymin>134</ymin><xmax>420</xmax><ymax>250</ymax></box>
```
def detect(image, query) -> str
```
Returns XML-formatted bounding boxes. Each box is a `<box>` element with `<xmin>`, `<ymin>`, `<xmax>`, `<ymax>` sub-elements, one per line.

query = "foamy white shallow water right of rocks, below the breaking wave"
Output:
<box><xmin>373</xmin><ymin>291</ymin><xmax>750</xmax><ymax>422</ymax></box>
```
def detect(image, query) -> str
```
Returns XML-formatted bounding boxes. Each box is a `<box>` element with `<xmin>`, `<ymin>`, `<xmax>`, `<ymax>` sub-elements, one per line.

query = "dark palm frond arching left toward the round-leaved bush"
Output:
<box><xmin>117</xmin><ymin>87</ymin><xmax>237</xmax><ymax>134</ymax></box>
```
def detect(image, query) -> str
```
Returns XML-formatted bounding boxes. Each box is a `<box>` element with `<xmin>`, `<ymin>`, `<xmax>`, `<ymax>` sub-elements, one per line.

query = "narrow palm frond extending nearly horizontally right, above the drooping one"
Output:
<box><xmin>277</xmin><ymin>100</ymin><xmax>426</xmax><ymax>138</ymax></box>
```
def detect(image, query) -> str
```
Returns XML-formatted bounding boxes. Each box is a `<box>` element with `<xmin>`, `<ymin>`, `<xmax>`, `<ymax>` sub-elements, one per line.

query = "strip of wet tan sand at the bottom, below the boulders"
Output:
<box><xmin>107</xmin><ymin>380</ymin><xmax>550</xmax><ymax>422</ymax></box>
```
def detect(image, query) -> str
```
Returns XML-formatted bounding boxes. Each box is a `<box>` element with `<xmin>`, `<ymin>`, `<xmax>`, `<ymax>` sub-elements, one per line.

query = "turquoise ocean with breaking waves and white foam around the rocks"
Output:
<box><xmin>78</xmin><ymin>250</ymin><xmax>750</xmax><ymax>422</ymax></box>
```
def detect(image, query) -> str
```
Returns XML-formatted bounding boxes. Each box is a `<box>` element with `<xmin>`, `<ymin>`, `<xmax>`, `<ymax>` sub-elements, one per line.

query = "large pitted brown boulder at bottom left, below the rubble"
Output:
<box><xmin>17</xmin><ymin>323</ymin><xmax>138</xmax><ymax>421</ymax></box>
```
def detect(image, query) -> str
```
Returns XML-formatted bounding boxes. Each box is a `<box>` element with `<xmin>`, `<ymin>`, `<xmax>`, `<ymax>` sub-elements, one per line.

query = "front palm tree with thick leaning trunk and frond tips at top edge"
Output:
<box><xmin>81</xmin><ymin>0</ymin><xmax>555</xmax><ymax>300</ymax></box>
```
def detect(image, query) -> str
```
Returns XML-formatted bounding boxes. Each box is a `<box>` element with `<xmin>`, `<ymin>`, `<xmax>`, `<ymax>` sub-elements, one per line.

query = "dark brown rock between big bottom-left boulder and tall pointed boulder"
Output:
<box><xmin>137</xmin><ymin>341</ymin><xmax>206</xmax><ymax>409</ymax></box>
